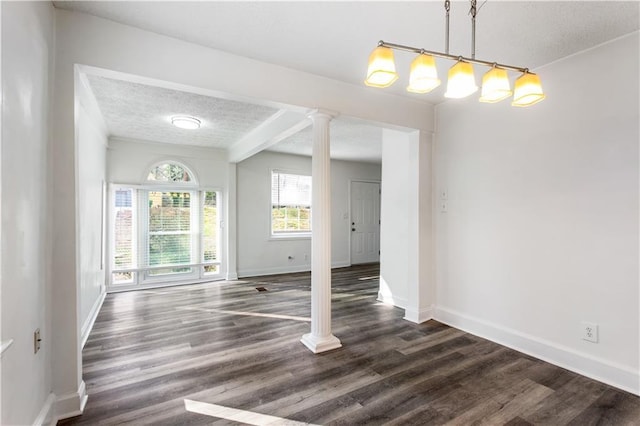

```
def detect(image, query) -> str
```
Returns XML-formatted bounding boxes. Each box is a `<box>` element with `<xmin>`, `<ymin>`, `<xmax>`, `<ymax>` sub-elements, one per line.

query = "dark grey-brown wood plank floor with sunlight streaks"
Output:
<box><xmin>59</xmin><ymin>265</ymin><xmax>640</xmax><ymax>425</ymax></box>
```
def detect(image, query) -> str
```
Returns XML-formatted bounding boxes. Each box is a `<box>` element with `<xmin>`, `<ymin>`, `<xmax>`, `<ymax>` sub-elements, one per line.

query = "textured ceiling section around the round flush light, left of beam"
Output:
<box><xmin>87</xmin><ymin>75</ymin><xmax>278</xmax><ymax>149</ymax></box>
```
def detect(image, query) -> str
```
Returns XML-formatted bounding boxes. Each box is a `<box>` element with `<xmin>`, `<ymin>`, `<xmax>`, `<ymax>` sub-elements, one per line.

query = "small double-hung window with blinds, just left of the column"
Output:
<box><xmin>271</xmin><ymin>170</ymin><xmax>311</xmax><ymax>236</ymax></box>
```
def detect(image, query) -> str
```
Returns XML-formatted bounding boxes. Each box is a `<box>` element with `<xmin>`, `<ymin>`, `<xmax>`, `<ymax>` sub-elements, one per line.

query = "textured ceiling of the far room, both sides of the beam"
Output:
<box><xmin>87</xmin><ymin>75</ymin><xmax>382</xmax><ymax>162</ymax></box>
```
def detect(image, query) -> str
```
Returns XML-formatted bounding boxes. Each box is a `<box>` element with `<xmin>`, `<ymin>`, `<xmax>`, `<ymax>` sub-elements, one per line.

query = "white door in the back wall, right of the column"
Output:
<box><xmin>351</xmin><ymin>182</ymin><xmax>380</xmax><ymax>264</ymax></box>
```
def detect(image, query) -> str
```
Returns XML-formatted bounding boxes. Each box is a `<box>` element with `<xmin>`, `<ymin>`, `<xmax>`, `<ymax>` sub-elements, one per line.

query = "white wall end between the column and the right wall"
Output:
<box><xmin>378</xmin><ymin>129</ymin><xmax>435</xmax><ymax>323</ymax></box>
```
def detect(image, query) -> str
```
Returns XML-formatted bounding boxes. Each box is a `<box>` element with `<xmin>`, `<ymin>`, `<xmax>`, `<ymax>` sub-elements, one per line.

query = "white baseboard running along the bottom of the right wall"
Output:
<box><xmin>434</xmin><ymin>307</ymin><xmax>640</xmax><ymax>395</ymax></box>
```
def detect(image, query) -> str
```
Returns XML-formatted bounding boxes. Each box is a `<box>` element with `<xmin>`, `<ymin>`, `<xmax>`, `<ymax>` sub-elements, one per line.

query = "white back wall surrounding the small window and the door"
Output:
<box><xmin>237</xmin><ymin>152</ymin><xmax>380</xmax><ymax>277</ymax></box>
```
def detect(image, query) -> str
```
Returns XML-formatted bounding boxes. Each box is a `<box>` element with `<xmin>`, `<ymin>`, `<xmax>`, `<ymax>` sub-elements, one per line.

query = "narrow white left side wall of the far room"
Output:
<box><xmin>76</xmin><ymin>76</ymin><xmax>107</xmax><ymax>342</ymax></box>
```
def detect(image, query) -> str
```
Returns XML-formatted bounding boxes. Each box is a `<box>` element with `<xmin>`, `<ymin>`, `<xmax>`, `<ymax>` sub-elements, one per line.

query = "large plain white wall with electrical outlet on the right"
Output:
<box><xmin>437</xmin><ymin>32</ymin><xmax>640</xmax><ymax>393</ymax></box>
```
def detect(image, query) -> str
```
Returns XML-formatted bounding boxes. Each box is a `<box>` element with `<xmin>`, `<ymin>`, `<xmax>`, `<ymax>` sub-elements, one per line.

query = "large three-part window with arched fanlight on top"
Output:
<box><xmin>110</xmin><ymin>162</ymin><xmax>222</xmax><ymax>286</ymax></box>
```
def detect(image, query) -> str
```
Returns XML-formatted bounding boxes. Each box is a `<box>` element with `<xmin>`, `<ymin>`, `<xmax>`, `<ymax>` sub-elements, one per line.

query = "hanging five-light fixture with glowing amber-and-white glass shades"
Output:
<box><xmin>364</xmin><ymin>0</ymin><xmax>545</xmax><ymax>107</ymax></box>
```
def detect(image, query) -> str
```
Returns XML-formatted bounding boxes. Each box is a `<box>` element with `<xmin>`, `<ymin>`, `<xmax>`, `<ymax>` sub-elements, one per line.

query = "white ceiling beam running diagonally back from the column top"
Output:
<box><xmin>228</xmin><ymin>109</ymin><xmax>311</xmax><ymax>163</ymax></box>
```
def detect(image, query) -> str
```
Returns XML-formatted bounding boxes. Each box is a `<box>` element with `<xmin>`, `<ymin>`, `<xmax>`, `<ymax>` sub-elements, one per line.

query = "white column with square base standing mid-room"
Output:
<box><xmin>301</xmin><ymin>110</ymin><xmax>342</xmax><ymax>353</ymax></box>
